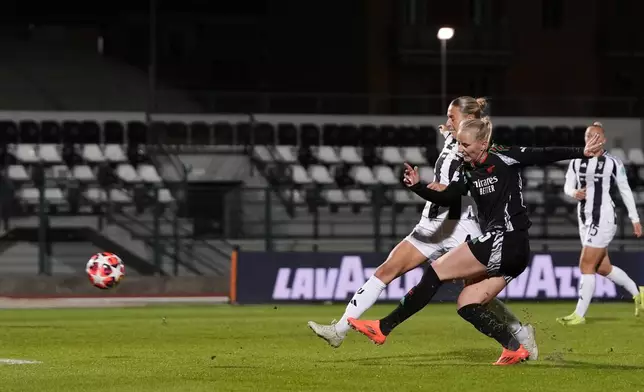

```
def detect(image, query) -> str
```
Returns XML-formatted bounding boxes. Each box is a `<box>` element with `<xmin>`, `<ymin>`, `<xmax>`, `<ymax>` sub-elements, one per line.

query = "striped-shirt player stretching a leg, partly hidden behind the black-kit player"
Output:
<box><xmin>308</xmin><ymin>97</ymin><xmax>538</xmax><ymax>359</ymax></box>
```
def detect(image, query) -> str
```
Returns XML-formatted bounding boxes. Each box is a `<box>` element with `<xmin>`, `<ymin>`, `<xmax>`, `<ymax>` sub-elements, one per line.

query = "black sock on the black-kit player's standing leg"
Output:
<box><xmin>458</xmin><ymin>304</ymin><xmax>520</xmax><ymax>351</ymax></box>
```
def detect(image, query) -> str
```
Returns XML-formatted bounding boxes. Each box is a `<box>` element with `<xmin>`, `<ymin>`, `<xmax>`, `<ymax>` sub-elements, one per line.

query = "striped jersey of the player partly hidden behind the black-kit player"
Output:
<box><xmin>423</xmin><ymin>131</ymin><xmax>476</xmax><ymax>220</ymax></box>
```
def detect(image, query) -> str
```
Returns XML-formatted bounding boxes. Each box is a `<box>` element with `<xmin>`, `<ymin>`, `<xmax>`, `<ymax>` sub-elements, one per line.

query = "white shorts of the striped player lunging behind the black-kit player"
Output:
<box><xmin>405</xmin><ymin>217</ymin><xmax>482</xmax><ymax>261</ymax></box>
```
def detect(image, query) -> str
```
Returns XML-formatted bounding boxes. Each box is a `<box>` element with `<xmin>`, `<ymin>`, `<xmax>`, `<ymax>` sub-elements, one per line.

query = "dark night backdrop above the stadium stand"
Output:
<box><xmin>2</xmin><ymin>0</ymin><xmax>644</xmax><ymax>116</ymax></box>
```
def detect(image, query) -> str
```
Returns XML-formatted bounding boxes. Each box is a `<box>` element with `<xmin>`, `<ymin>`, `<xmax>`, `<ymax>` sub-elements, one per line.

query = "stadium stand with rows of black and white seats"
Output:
<box><xmin>0</xmin><ymin>114</ymin><xmax>644</xmax><ymax>268</ymax></box>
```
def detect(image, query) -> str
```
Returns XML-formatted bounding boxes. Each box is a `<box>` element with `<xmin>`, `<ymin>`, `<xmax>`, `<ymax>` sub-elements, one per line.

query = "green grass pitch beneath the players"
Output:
<box><xmin>0</xmin><ymin>302</ymin><xmax>644</xmax><ymax>392</ymax></box>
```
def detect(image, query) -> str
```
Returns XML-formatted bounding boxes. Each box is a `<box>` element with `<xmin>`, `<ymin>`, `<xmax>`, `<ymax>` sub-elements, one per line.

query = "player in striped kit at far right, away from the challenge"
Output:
<box><xmin>557</xmin><ymin>122</ymin><xmax>644</xmax><ymax>325</ymax></box>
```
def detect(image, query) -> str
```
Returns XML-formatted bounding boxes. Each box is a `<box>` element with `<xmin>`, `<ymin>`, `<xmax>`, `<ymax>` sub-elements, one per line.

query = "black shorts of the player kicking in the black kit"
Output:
<box><xmin>467</xmin><ymin>230</ymin><xmax>530</xmax><ymax>283</ymax></box>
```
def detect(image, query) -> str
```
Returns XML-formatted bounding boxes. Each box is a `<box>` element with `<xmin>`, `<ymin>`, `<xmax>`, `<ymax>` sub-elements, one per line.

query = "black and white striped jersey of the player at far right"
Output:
<box><xmin>564</xmin><ymin>152</ymin><xmax>639</xmax><ymax>226</ymax></box>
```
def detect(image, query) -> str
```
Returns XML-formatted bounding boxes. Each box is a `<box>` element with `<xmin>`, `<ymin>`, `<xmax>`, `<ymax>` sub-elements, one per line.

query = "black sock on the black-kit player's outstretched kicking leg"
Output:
<box><xmin>380</xmin><ymin>265</ymin><xmax>443</xmax><ymax>335</ymax></box>
